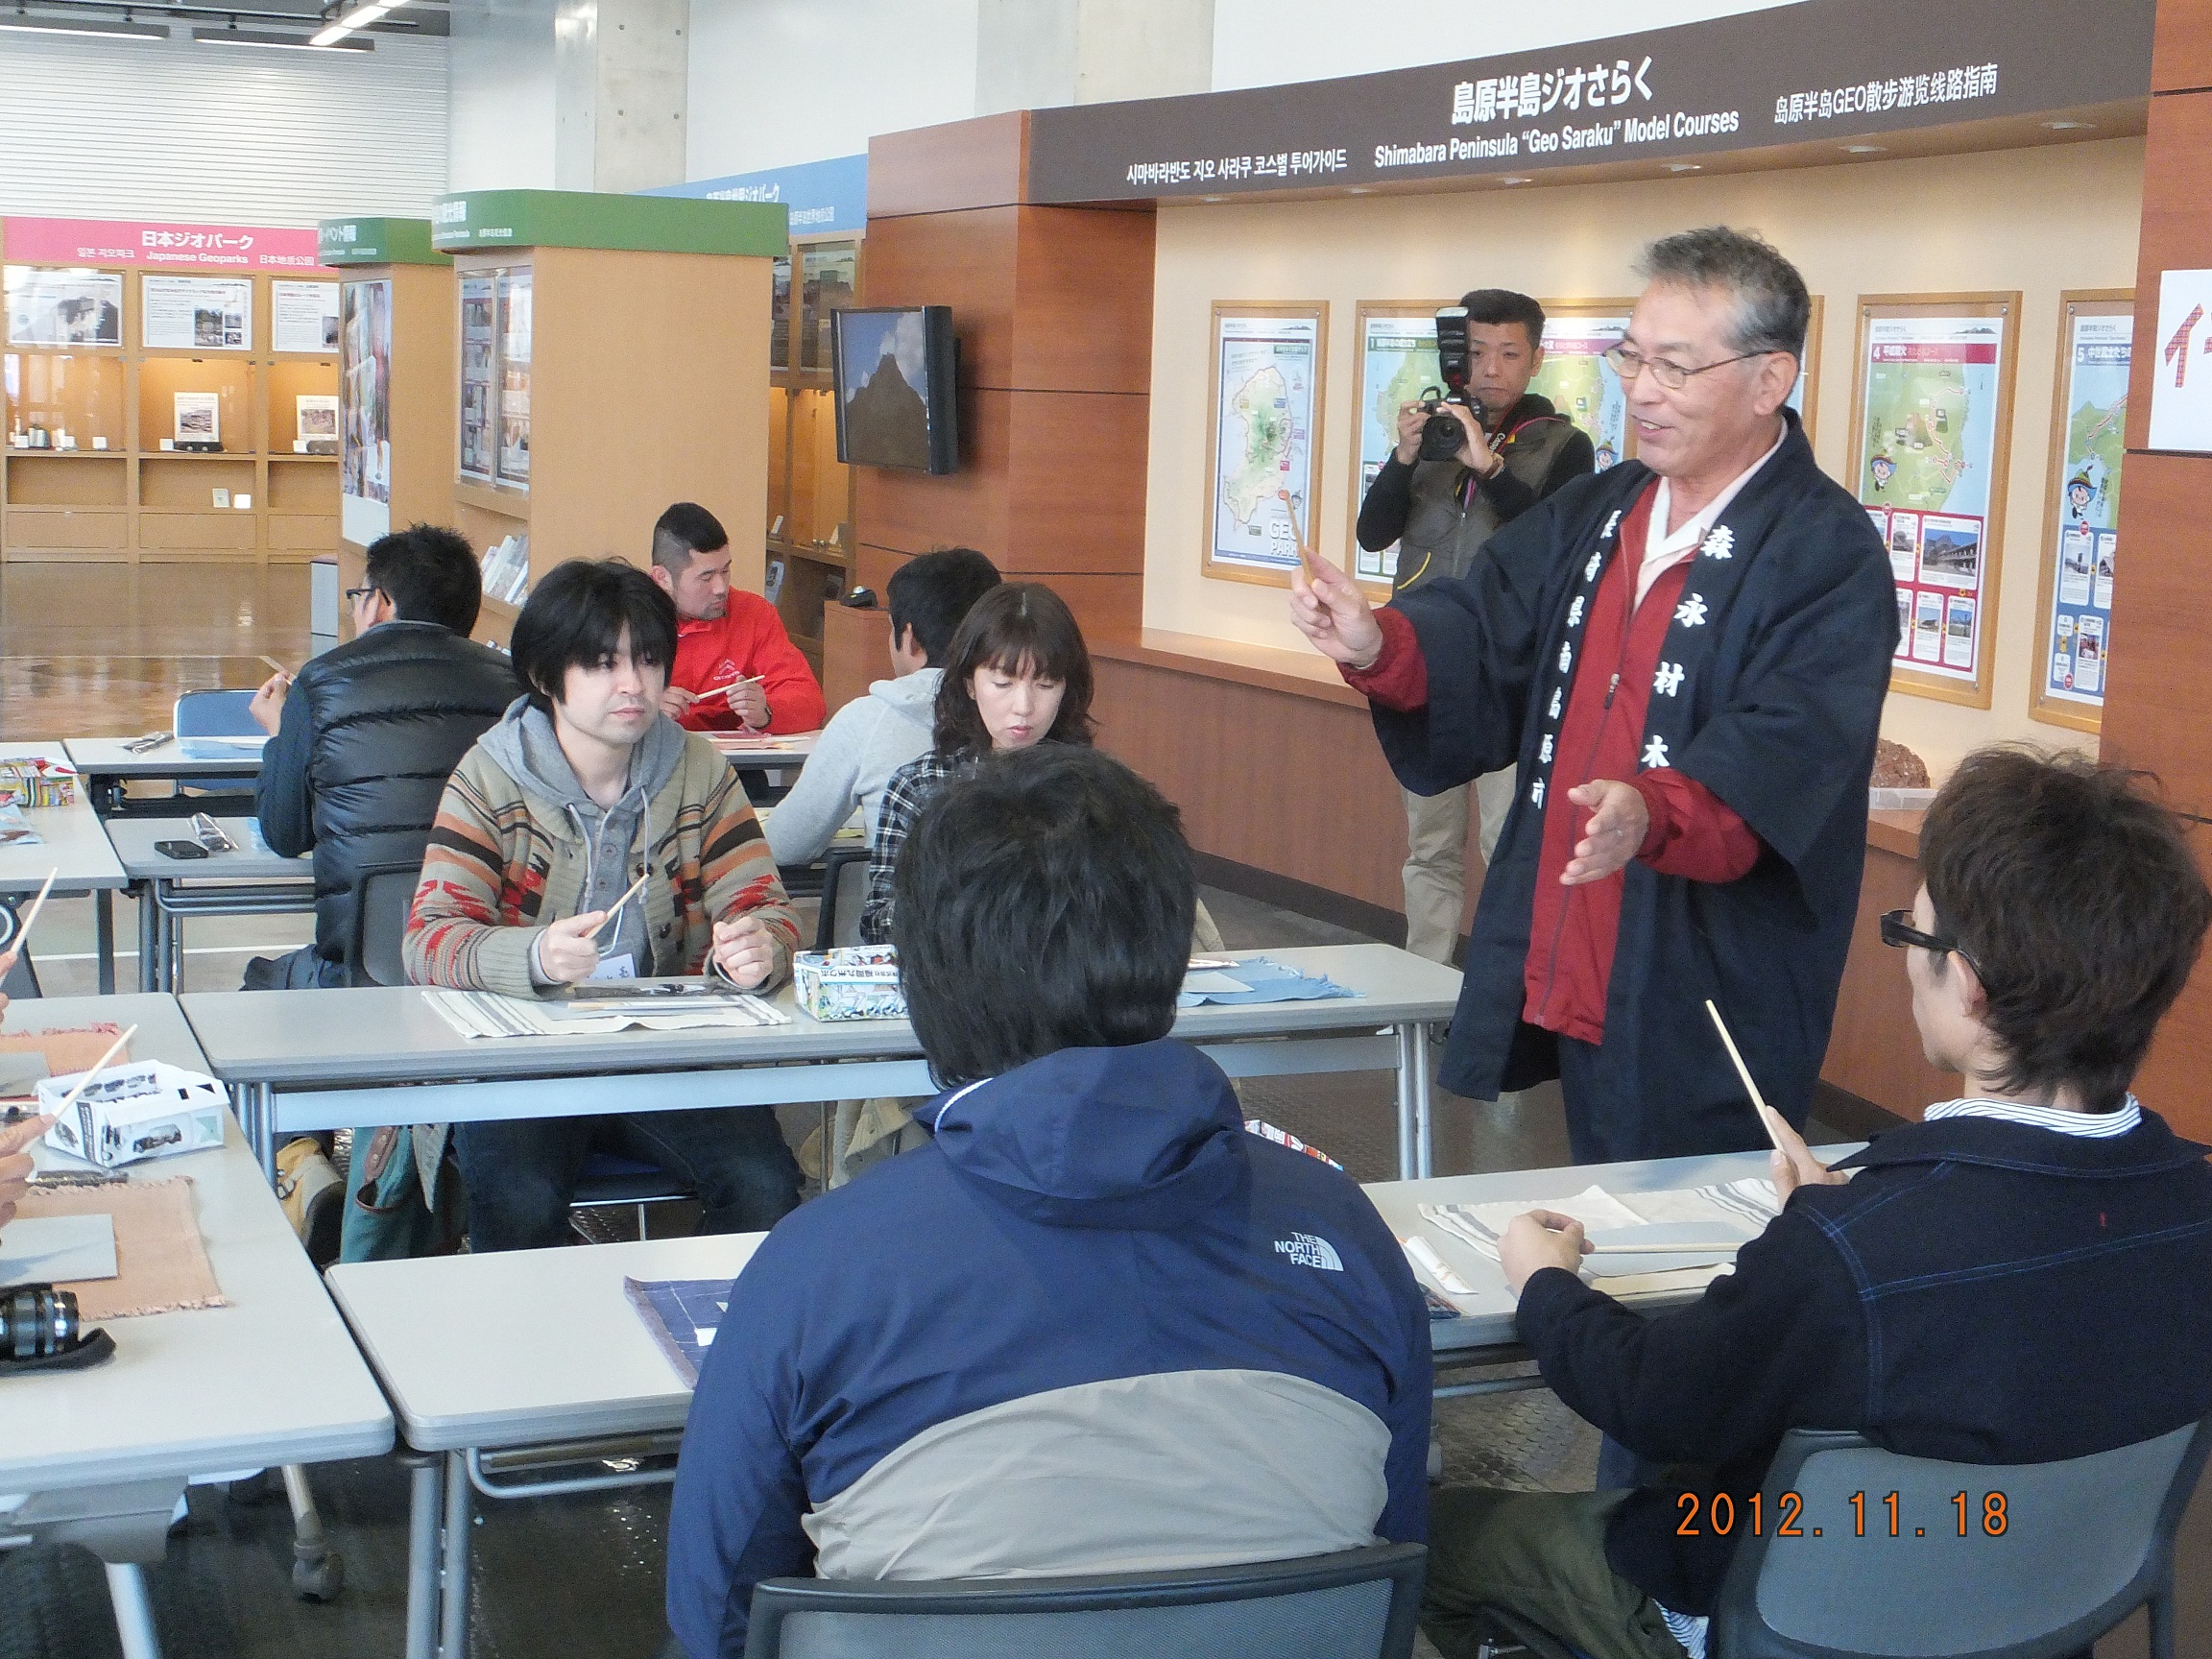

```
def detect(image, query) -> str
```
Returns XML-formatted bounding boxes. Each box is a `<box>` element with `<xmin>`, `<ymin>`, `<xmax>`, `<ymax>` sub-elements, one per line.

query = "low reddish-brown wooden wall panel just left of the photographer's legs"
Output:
<box><xmin>1093</xmin><ymin>660</ymin><xmax>1405</xmax><ymax>914</ymax></box>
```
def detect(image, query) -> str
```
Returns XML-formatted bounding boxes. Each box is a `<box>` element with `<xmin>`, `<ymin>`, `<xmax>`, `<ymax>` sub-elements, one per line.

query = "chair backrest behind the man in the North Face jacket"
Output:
<box><xmin>745</xmin><ymin>1544</ymin><xmax>1429</xmax><ymax>1659</ymax></box>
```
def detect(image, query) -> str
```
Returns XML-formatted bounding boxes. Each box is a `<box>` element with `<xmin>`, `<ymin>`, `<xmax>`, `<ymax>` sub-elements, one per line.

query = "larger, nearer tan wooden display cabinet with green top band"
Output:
<box><xmin>434</xmin><ymin>190</ymin><xmax>787</xmax><ymax>639</ymax></box>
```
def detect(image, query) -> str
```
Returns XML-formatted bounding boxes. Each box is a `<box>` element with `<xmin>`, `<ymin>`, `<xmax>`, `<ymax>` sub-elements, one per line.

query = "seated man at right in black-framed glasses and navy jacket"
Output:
<box><xmin>1422</xmin><ymin>748</ymin><xmax>2212</xmax><ymax>1659</ymax></box>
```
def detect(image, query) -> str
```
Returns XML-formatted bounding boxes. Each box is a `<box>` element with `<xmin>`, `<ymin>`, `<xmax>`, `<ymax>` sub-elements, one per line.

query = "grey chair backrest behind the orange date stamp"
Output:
<box><xmin>1701</xmin><ymin>1418</ymin><xmax>2212</xmax><ymax>1659</ymax></box>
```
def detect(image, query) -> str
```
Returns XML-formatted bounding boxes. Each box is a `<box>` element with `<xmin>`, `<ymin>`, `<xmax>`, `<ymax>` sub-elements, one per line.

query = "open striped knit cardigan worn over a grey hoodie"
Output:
<box><xmin>405</xmin><ymin>733</ymin><xmax>799</xmax><ymax>996</ymax></box>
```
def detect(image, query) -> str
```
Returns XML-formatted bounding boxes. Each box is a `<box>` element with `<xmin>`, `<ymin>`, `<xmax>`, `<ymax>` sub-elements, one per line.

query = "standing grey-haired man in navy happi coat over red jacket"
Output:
<box><xmin>1292</xmin><ymin>226</ymin><xmax>1898</xmax><ymax>1162</ymax></box>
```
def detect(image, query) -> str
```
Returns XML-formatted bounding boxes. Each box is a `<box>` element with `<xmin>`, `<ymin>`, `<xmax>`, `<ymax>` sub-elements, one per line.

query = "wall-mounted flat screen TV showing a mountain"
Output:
<box><xmin>830</xmin><ymin>305</ymin><xmax>960</xmax><ymax>473</ymax></box>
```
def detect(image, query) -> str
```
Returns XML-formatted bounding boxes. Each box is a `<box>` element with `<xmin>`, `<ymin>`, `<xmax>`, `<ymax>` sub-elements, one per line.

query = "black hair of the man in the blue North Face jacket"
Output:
<box><xmin>892</xmin><ymin>743</ymin><xmax>1196</xmax><ymax>1089</ymax></box>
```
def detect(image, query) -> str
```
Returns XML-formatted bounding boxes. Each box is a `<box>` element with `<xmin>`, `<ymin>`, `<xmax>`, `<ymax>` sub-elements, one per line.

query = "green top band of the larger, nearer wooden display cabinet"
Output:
<box><xmin>431</xmin><ymin>190</ymin><xmax>790</xmax><ymax>256</ymax></box>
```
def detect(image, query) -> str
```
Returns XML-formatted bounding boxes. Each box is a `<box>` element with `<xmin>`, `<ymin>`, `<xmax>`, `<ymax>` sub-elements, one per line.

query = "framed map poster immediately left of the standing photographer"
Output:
<box><xmin>1206</xmin><ymin>305</ymin><xmax>1327</xmax><ymax>584</ymax></box>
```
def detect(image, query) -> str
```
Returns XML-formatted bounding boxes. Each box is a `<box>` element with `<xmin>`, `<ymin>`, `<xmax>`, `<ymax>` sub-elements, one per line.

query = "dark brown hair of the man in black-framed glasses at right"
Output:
<box><xmin>1920</xmin><ymin>748</ymin><xmax>2212</xmax><ymax>1113</ymax></box>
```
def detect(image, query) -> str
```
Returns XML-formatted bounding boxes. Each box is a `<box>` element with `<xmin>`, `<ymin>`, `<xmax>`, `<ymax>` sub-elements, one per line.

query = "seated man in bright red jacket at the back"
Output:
<box><xmin>653</xmin><ymin>502</ymin><xmax>830</xmax><ymax>733</ymax></box>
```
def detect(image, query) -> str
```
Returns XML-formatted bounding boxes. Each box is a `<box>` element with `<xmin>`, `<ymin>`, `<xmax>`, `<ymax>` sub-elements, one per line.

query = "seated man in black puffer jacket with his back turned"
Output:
<box><xmin>246</xmin><ymin>524</ymin><xmax>519</xmax><ymax>991</ymax></box>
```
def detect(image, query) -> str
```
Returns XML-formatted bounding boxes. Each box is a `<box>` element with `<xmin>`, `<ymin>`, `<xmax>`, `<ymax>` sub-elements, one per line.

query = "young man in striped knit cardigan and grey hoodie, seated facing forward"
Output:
<box><xmin>407</xmin><ymin>560</ymin><xmax>799</xmax><ymax>1250</ymax></box>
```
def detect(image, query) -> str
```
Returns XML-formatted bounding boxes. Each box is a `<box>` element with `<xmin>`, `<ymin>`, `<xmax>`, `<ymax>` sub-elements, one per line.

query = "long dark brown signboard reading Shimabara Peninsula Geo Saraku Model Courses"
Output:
<box><xmin>1028</xmin><ymin>0</ymin><xmax>2156</xmax><ymax>202</ymax></box>
